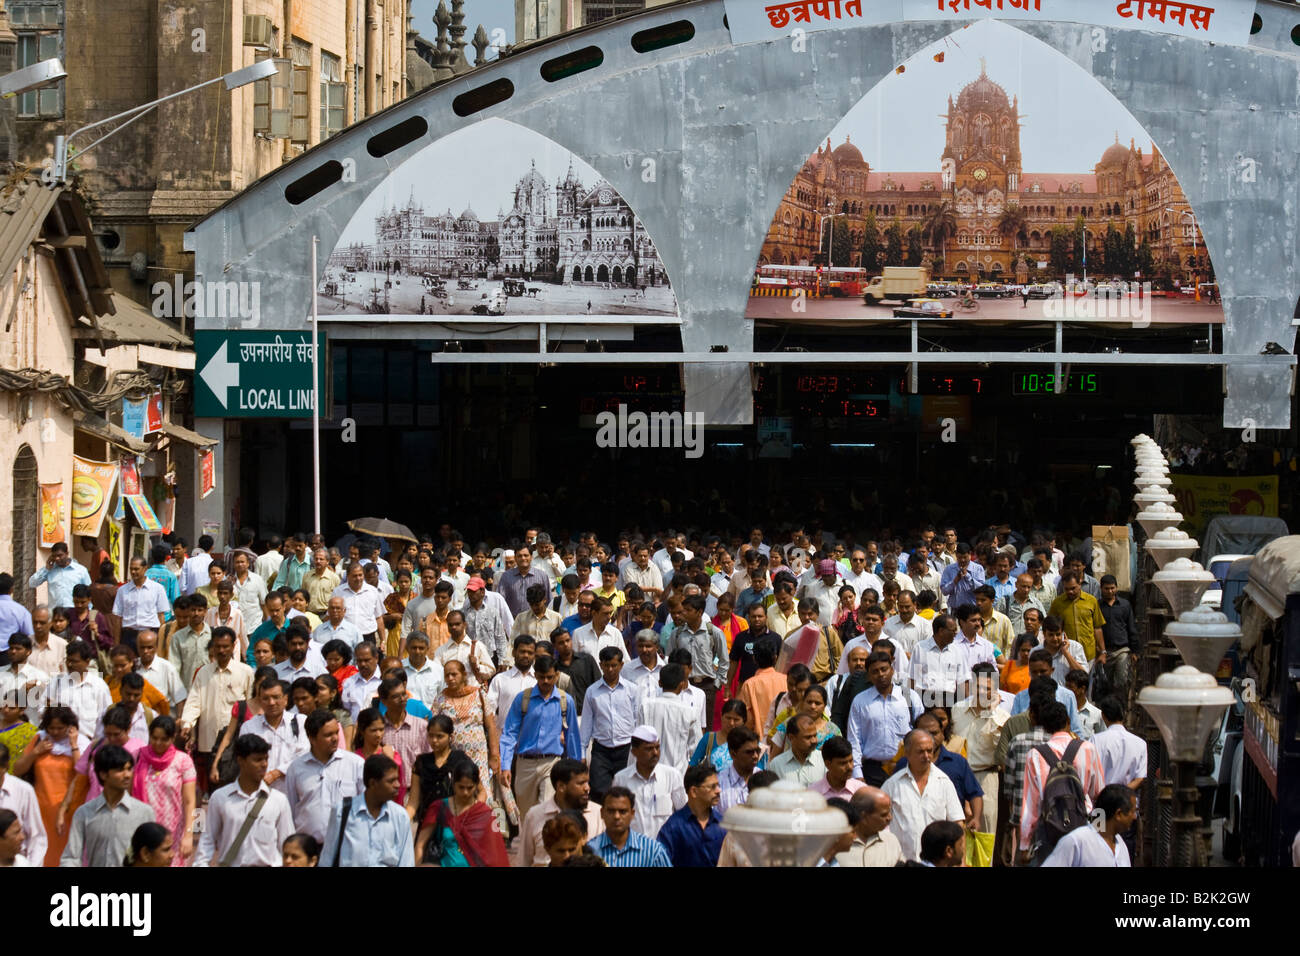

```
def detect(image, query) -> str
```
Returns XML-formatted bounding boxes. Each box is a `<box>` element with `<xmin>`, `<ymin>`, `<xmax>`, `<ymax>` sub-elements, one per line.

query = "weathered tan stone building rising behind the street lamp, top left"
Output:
<box><xmin>7</xmin><ymin>0</ymin><xmax>407</xmax><ymax>302</ymax></box>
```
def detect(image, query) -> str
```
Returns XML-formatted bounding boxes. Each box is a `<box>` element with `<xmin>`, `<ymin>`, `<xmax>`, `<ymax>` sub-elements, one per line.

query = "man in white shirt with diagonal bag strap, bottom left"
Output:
<box><xmin>194</xmin><ymin>734</ymin><xmax>294</xmax><ymax>866</ymax></box>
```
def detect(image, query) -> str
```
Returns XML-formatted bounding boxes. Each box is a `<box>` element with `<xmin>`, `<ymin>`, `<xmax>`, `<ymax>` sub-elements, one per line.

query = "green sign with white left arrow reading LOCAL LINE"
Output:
<box><xmin>194</xmin><ymin>329</ymin><xmax>330</xmax><ymax>419</ymax></box>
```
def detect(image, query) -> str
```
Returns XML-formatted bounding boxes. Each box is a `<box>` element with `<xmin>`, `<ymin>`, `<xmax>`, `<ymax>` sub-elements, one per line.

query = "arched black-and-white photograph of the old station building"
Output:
<box><xmin>320</xmin><ymin>120</ymin><xmax>676</xmax><ymax>315</ymax></box>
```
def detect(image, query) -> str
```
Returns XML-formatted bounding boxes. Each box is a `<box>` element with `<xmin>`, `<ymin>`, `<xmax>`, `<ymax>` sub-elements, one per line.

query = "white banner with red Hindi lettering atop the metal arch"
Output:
<box><xmin>725</xmin><ymin>0</ymin><xmax>1255</xmax><ymax>46</ymax></box>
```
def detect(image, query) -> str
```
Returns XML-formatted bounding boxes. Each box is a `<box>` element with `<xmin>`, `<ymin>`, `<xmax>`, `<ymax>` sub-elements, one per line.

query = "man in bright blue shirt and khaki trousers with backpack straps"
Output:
<box><xmin>501</xmin><ymin>656</ymin><xmax>582</xmax><ymax>819</ymax></box>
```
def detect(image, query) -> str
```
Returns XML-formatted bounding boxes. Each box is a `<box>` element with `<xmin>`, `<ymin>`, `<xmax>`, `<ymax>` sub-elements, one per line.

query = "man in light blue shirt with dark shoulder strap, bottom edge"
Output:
<box><xmin>320</xmin><ymin>753</ymin><xmax>415</xmax><ymax>866</ymax></box>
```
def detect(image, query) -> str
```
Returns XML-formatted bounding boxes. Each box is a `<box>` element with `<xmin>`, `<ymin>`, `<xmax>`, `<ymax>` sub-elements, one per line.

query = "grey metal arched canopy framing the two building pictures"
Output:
<box><xmin>186</xmin><ymin>0</ymin><xmax>1300</xmax><ymax>428</ymax></box>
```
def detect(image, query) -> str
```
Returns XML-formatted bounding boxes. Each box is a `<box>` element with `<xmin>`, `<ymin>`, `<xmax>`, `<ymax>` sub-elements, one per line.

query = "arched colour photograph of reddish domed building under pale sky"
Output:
<box><xmin>750</xmin><ymin>22</ymin><xmax>1213</xmax><ymax>323</ymax></box>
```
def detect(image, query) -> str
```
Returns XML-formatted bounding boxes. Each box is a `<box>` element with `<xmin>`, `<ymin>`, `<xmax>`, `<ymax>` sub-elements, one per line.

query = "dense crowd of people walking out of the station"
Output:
<box><xmin>0</xmin><ymin>524</ymin><xmax>1147</xmax><ymax>866</ymax></box>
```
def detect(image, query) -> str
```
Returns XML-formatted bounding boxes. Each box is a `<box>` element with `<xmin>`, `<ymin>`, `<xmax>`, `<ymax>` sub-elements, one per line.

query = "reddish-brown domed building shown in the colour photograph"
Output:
<box><xmin>759</xmin><ymin>65</ymin><xmax>1206</xmax><ymax>283</ymax></box>
